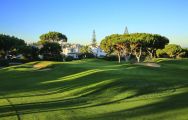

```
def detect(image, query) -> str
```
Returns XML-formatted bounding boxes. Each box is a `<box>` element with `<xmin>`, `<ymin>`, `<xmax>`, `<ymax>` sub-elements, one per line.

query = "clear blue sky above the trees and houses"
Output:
<box><xmin>0</xmin><ymin>0</ymin><xmax>188</xmax><ymax>47</ymax></box>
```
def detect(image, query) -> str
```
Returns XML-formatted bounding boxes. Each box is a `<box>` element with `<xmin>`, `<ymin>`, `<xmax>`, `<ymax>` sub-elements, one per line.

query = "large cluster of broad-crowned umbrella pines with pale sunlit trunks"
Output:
<box><xmin>100</xmin><ymin>33</ymin><xmax>169</xmax><ymax>62</ymax></box>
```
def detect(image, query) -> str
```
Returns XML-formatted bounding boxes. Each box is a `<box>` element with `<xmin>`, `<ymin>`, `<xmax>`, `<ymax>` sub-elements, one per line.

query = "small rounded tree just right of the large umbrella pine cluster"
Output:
<box><xmin>164</xmin><ymin>44</ymin><xmax>183</xmax><ymax>58</ymax></box>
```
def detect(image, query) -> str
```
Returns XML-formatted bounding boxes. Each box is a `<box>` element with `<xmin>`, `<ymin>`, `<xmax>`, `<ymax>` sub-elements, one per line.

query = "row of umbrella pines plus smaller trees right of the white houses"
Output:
<box><xmin>100</xmin><ymin>33</ymin><xmax>186</xmax><ymax>63</ymax></box>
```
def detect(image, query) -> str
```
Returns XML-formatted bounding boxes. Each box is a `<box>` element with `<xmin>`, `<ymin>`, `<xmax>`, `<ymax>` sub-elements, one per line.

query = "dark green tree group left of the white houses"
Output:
<box><xmin>0</xmin><ymin>32</ymin><xmax>67</xmax><ymax>64</ymax></box>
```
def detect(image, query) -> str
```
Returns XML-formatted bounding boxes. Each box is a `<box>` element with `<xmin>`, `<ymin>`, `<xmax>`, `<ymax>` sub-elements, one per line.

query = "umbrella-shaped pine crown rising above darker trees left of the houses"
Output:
<box><xmin>40</xmin><ymin>32</ymin><xmax>67</xmax><ymax>43</ymax></box>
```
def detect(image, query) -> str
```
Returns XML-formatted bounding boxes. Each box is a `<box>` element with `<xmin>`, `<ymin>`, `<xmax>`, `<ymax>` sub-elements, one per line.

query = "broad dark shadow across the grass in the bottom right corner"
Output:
<box><xmin>86</xmin><ymin>91</ymin><xmax>188</xmax><ymax>120</ymax></box>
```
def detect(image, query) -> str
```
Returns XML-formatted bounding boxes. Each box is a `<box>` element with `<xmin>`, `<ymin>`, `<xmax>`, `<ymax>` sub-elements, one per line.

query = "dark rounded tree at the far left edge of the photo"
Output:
<box><xmin>0</xmin><ymin>34</ymin><xmax>26</xmax><ymax>59</ymax></box>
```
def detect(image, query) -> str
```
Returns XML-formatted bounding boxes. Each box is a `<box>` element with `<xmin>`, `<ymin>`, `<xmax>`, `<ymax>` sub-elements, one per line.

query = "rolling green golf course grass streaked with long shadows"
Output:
<box><xmin>0</xmin><ymin>59</ymin><xmax>188</xmax><ymax>120</ymax></box>
